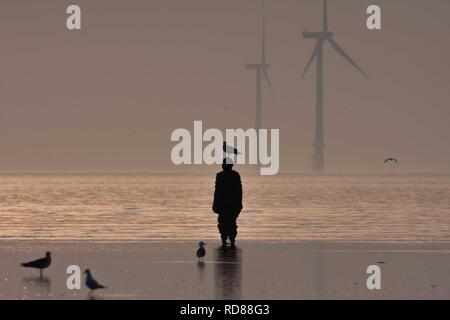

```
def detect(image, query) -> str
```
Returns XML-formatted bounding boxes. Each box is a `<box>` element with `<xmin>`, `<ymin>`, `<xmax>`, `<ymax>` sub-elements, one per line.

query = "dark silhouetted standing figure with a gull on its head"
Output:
<box><xmin>213</xmin><ymin>158</ymin><xmax>242</xmax><ymax>249</ymax></box>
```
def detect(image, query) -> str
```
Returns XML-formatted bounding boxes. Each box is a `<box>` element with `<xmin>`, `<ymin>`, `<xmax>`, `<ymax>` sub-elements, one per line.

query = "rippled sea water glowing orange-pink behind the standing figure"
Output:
<box><xmin>0</xmin><ymin>174</ymin><xmax>450</xmax><ymax>243</ymax></box>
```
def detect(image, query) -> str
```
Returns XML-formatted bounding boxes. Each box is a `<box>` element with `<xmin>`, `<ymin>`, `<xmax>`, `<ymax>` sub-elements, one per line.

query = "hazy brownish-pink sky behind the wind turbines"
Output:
<box><xmin>0</xmin><ymin>0</ymin><xmax>450</xmax><ymax>172</ymax></box>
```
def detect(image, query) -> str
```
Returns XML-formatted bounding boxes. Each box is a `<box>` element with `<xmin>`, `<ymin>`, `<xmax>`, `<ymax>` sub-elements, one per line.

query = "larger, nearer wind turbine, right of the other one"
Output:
<box><xmin>302</xmin><ymin>0</ymin><xmax>368</xmax><ymax>172</ymax></box>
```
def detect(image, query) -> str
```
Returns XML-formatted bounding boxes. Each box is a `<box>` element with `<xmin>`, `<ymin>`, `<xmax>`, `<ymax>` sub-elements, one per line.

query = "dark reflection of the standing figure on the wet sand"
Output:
<box><xmin>214</xmin><ymin>248</ymin><xmax>242</xmax><ymax>300</ymax></box>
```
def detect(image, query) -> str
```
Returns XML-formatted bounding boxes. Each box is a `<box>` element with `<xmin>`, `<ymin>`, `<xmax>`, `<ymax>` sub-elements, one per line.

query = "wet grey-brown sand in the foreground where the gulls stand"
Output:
<box><xmin>0</xmin><ymin>241</ymin><xmax>450</xmax><ymax>300</ymax></box>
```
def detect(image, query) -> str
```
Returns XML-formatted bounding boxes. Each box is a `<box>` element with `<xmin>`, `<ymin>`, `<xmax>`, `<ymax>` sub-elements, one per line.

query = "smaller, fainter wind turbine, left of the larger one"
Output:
<box><xmin>245</xmin><ymin>1</ymin><xmax>275</xmax><ymax>145</ymax></box>
